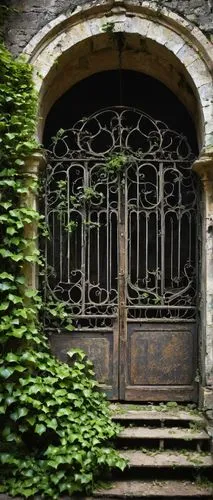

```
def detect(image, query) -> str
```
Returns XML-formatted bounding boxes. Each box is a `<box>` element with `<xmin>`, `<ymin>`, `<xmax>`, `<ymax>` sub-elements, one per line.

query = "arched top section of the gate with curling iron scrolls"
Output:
<box><xmin>48</xmin><ymin>106</ymin><xmax>195</xmax><ymax>162</ymax></box>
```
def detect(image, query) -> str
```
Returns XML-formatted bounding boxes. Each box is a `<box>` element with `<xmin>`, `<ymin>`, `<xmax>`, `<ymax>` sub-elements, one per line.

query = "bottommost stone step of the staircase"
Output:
<box><xmin>93</xmin><ymin>481</ymin><xmax>213</xmax><ymax>500</ymax></box>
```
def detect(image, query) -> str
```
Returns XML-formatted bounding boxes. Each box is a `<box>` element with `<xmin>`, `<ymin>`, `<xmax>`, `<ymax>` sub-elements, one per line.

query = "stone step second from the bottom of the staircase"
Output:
<box><xmin>120</xmin><ymin>450</ymin><xmax>213</xmax><ymax>470</ymax></box>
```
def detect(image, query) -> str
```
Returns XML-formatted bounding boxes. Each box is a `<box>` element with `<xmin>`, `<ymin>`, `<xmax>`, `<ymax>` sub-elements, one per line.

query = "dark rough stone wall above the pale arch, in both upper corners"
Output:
<box><xmin>4</xmin><ymin>0</ymin><xmax>213</xmax><ymax>54</ymax></box>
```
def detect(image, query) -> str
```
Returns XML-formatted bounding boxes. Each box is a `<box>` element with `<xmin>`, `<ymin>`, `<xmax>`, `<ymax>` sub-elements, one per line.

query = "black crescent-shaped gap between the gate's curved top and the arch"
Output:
<box><xmin>43</xmin><ymin>70</ymin><xmax>197</xmax><ymax>155</ymax></box>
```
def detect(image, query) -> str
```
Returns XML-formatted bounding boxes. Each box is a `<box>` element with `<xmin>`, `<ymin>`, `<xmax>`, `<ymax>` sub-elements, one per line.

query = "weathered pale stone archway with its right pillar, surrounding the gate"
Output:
<box><xmin>22</xmin><ymin>1</ymin><xmax>213</xmax><ymax>407</ymax></box>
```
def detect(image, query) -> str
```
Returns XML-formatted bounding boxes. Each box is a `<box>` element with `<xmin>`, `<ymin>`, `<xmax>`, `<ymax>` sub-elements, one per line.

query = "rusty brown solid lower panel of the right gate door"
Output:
<box><xmin>125</xmin><ymin>322</ymin><xmax>197</xmax><ymax>401</ymax></box>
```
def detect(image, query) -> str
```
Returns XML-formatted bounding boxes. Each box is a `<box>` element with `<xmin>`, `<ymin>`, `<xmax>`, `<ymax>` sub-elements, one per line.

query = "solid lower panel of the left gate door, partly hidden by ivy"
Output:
<box><xmin>50</xmin><ymin>331</ymin><xmax>118</xmax><ymax>399</ymax></box>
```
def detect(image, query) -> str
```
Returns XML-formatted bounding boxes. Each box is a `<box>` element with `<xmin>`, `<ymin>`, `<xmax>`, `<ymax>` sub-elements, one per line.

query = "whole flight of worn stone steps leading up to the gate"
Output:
<box><xmin>91</xmin><ymin>404</ymin><xmax>213</xmax><ymax>500</ymax></box>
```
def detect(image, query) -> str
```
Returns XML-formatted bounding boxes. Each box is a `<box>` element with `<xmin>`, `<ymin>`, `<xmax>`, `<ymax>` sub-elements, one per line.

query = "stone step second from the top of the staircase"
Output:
<box><xmin>118</xmin><ymin>427</ymin><xmax>209</xmax><ymax>441</ymax></box>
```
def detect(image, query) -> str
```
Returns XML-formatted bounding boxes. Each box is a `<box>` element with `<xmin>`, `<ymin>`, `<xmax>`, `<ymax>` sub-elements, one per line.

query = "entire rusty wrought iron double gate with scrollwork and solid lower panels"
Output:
<box><xmin>44</xmin><ymin>107</ymin><xmax>199</xmax><ymax>400</ymax></box>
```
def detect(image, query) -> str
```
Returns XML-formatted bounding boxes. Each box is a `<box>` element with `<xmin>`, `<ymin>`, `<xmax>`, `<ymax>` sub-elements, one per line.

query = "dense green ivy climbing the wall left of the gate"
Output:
<box><xmin>0</xmin><ymin>44</ymin><xmax>125</xmax><ymax>499</ymax></box>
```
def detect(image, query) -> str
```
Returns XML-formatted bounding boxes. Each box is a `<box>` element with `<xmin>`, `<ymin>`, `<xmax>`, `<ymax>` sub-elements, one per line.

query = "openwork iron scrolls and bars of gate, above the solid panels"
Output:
<box><xmin>44</xmin><ymin>107</ymin><xmax>198</xmax><ymax>328</ymax></box>
